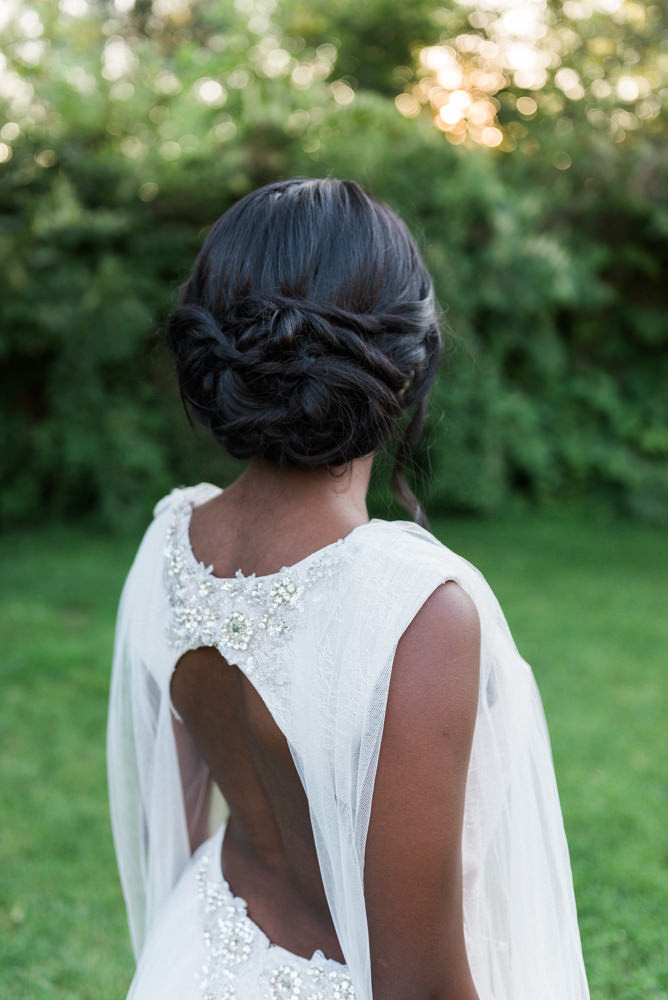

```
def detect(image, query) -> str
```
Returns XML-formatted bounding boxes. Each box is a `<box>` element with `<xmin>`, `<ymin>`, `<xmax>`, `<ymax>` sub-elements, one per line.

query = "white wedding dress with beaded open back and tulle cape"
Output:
<box><xmin>108</xmin><ymin>484</ymin><xmax>589</xmax><ymax>1000</ymax></box>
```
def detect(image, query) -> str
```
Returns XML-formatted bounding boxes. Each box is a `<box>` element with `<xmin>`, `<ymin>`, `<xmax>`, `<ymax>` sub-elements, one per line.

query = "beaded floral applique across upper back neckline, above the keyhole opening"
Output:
<box><xmin>165</xmin><ymin>500</ymin><xmax>341</xmax><ymax>676</ymax></box>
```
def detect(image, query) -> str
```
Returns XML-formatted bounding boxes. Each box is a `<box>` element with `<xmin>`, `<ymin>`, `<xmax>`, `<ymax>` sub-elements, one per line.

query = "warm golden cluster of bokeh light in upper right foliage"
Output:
<box><xmin>395</xmin><ymin>0</ymin><xmax>666</xmax><ymax>150</ymax></box>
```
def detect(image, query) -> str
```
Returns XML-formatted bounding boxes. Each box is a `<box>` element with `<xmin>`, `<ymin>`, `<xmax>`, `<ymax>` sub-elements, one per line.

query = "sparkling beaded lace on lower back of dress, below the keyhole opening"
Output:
<box><xmin>197</xmin><ymin>837</ymin><xmax>355</xmax><ymax>1000</ymax></box>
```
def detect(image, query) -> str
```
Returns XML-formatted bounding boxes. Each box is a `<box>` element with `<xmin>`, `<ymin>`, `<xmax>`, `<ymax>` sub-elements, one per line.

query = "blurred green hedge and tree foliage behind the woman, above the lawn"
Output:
<box><xmin>0</xmin><ymin>0</ymin><xmax>668</xmax><ymax>524</ymax></box>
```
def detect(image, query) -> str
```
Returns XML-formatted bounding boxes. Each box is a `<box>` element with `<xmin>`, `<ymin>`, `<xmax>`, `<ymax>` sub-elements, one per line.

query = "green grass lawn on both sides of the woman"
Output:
<box><xmin>0</xmin><ymin>514</ymin><xmax>668</xmax><ymax>1000</ymax></box>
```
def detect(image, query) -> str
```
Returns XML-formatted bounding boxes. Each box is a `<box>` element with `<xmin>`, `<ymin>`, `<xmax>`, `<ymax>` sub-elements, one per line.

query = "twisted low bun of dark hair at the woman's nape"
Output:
<box><xmin>168</xmin><ymin>296</ymin><xmax>423</xmax><ymax>465</ymax></box>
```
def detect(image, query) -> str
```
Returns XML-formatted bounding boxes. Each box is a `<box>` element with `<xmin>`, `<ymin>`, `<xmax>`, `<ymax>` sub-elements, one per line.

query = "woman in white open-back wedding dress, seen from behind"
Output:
<box><xmin>108</xmin><ymin>180</ymin><xmax>588</xmax><ymax>1000</ymax></box>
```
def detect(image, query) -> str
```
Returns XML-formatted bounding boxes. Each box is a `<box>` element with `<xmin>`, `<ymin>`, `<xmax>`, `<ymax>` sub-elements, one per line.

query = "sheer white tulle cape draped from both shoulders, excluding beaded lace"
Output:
<box><xmin>108</xmin><ymin>484</ymin><xmax>589</xmax><ymax>1000</ymax></box>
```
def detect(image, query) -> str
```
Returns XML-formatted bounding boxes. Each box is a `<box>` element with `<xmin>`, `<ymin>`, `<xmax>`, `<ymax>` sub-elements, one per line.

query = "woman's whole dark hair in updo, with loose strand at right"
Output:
<box><xmin>167</xmin><ymin>179</ymin><xmax>441</xmax><ymax>520</ymax></box>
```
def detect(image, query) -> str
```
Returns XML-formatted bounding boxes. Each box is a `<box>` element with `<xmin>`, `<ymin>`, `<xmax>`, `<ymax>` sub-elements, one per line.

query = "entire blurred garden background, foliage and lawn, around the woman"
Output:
<box><xmin>0</xmin><ymin>0</ymin><xmax>668</xmax><ymax>1000</ymax></box>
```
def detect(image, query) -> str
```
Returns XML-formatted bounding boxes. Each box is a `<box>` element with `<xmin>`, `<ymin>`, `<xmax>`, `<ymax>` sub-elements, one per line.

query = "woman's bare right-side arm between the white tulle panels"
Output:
<box><xmin>364</xmin><ymin>582</ymin><xmax>480</xmax><ymax>1000</ymax></box>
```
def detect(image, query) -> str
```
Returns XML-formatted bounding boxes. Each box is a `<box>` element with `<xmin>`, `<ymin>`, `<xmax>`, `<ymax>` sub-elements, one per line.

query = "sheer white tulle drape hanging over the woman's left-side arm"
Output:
<box><xmin>107</xmin><ymin>488</ymin><xmax>210</xmax><ymax>957</ymax></box>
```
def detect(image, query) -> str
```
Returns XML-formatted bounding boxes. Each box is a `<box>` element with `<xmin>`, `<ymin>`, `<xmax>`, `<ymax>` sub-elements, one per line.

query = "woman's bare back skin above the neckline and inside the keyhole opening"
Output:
<box><xmin>171</xmin><ymin>480</ymin><xmax>365</xmax><ymax>962</ymax></box>
